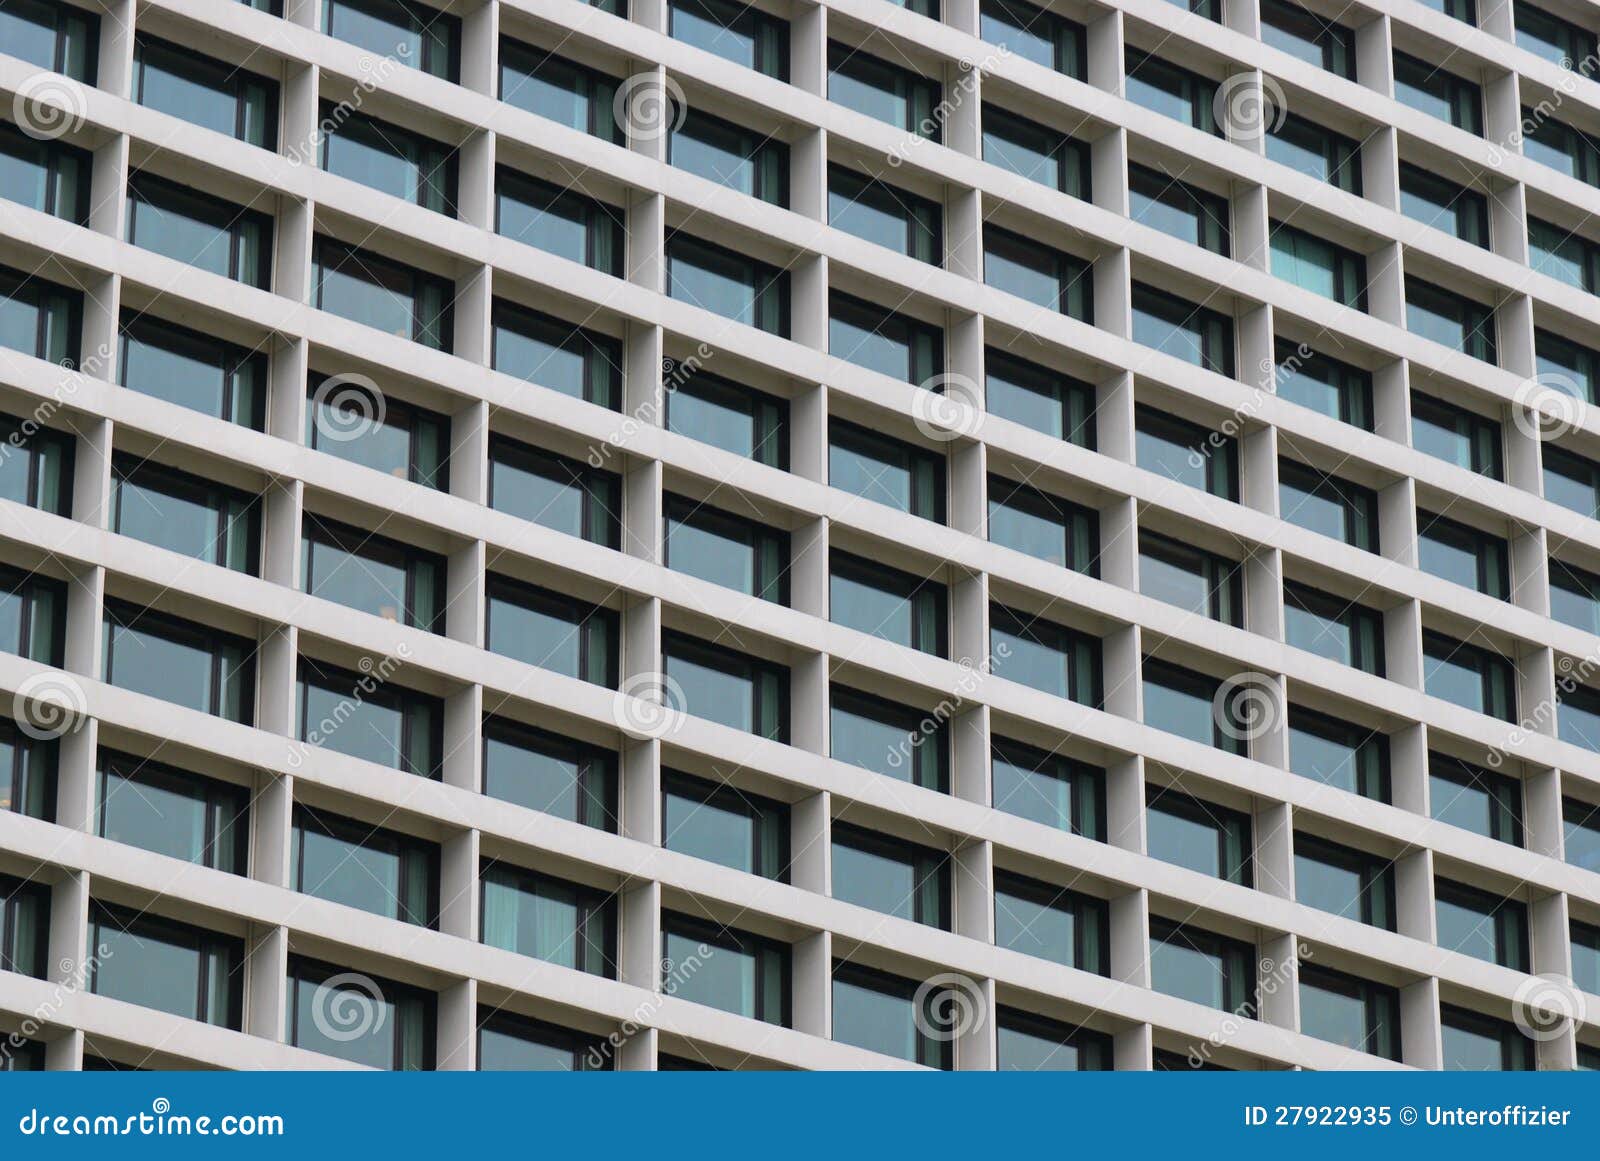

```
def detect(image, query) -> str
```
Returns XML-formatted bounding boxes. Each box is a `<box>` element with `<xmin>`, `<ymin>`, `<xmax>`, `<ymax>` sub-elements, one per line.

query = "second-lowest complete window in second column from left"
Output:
<box><xmin>94</xmin><ymin>750</ymin><xmax>250</xmax><ymax>875</ymax></box>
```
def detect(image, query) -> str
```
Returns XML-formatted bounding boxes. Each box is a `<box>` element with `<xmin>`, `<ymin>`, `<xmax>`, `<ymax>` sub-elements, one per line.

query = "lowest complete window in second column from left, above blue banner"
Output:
<box><xmin>88</xmin><ymin>902</ymin><xmax>245</xmax><ymax>1031</ymax></box>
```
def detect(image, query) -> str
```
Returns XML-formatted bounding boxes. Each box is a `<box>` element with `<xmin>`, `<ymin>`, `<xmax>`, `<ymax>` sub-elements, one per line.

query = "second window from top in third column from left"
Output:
<box><xmin>317</xmin><ymin>101</ymin><xmax>458</xmax><ymax>217</ymax></box>
